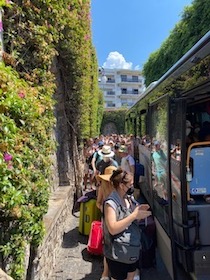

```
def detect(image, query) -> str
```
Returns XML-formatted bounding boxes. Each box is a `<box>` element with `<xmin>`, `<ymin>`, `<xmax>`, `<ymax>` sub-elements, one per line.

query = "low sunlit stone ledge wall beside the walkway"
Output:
<box><xmin>31</xmin><ymin>185</ymin><xmax>74</xmax><ymax>280</ymax></box>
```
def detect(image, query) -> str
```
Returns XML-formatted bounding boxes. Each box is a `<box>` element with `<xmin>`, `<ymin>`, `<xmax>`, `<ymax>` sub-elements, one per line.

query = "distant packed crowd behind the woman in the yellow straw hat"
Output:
<box><xmin>83</xmin><ymin>134</ymin><xmax>135</xmax><ymax>190</ymax></box>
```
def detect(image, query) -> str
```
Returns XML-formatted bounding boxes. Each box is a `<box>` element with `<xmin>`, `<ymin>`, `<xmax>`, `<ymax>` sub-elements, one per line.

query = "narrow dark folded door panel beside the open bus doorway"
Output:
<box><xmin>169</xmin><ymin>98</ymin><xmax>195</xmax><ymax>270</ymax></box>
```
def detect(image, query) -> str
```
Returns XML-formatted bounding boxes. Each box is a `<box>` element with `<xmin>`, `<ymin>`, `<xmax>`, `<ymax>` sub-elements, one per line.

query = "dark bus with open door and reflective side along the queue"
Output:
<box><xmin>126</xmin><ymin>31</ymin><xmax>210</xmax><ymax>280</ymax></box>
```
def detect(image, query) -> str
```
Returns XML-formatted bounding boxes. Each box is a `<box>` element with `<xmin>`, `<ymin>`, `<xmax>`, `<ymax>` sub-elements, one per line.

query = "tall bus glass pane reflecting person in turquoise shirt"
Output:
<box><xmin>149</xmin><ymin>97</ymin><xmax>168</xmax><ymax>230</ymax></box>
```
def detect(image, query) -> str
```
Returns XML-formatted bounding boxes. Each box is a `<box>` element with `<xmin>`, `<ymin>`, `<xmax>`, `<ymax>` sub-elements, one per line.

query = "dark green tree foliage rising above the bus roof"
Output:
<box><xmin>143</xmin><ymin>0</ymin><xmax>210</xmax><ymax>86</ymax></box>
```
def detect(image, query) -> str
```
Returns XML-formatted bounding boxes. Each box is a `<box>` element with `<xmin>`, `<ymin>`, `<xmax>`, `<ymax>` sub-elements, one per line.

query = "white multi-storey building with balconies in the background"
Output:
<box><xmin>99</xmin><ymin>68</ymin><xmax>145</xmax><ymax>110</ymax></box>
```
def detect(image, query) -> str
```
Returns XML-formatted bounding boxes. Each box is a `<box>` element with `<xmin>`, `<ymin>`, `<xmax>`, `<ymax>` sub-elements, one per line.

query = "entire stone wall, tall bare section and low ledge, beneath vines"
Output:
<box><xmin>26</xmin><ymin>57</ymin><xmax>84</xmax><ymax>280</ymax></box>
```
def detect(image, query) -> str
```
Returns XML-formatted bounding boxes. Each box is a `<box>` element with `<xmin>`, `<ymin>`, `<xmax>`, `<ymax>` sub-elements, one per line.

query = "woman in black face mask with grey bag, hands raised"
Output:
<box><xmin>104</xmin><ymin>168</ymin><xmax>151</xmax><ymax>280</ymax></box>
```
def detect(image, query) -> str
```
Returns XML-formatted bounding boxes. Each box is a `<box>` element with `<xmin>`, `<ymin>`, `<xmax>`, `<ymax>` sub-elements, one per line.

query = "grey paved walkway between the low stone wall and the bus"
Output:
<box><xmin>50</xmin><ymin>212</ymin><xmax>171</xmax><ymax>280</ymax></box>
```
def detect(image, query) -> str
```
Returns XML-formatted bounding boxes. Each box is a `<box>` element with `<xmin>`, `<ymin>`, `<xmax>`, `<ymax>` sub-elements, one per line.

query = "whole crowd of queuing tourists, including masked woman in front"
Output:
<box><xmin>83</xmin><ymin>134</ymin><xmax>151</xmax><ymax>280</ymax></box>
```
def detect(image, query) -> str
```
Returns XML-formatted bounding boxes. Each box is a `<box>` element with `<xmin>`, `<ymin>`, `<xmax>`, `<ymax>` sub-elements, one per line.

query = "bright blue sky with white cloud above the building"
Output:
<box><xmin>91</xmin><ymin>0</ymin><xmax>193</xmax><ymax>69</ymax></box>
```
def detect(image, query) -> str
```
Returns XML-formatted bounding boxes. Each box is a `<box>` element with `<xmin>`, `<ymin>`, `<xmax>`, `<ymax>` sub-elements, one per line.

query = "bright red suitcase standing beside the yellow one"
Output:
<box><xmin>87</xmin><ymin>221</ymin><xmax>103</xmax><ymax>255</ymax></box>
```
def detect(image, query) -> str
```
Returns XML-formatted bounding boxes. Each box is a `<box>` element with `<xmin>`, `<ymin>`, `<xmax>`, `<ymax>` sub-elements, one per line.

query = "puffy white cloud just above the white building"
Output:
<box><xmin>103</xmin><ymin>51</ymin><xmax>133</xmax><ymax>69</ymax></box>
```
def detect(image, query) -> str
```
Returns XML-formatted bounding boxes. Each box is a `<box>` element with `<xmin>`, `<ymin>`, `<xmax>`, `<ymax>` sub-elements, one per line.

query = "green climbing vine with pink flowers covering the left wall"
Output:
<box><xmin>0</xmin><ymin>0</ymin><xmax>103</xmax><ymax>280</ymax></box>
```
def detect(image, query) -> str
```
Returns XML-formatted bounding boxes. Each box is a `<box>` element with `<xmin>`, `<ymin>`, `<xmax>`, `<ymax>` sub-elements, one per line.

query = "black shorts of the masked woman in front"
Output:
<box><xmin>106</xmin><ymin>259</ymin><xmax>139</xmax><ymax>280</ymax></box>
